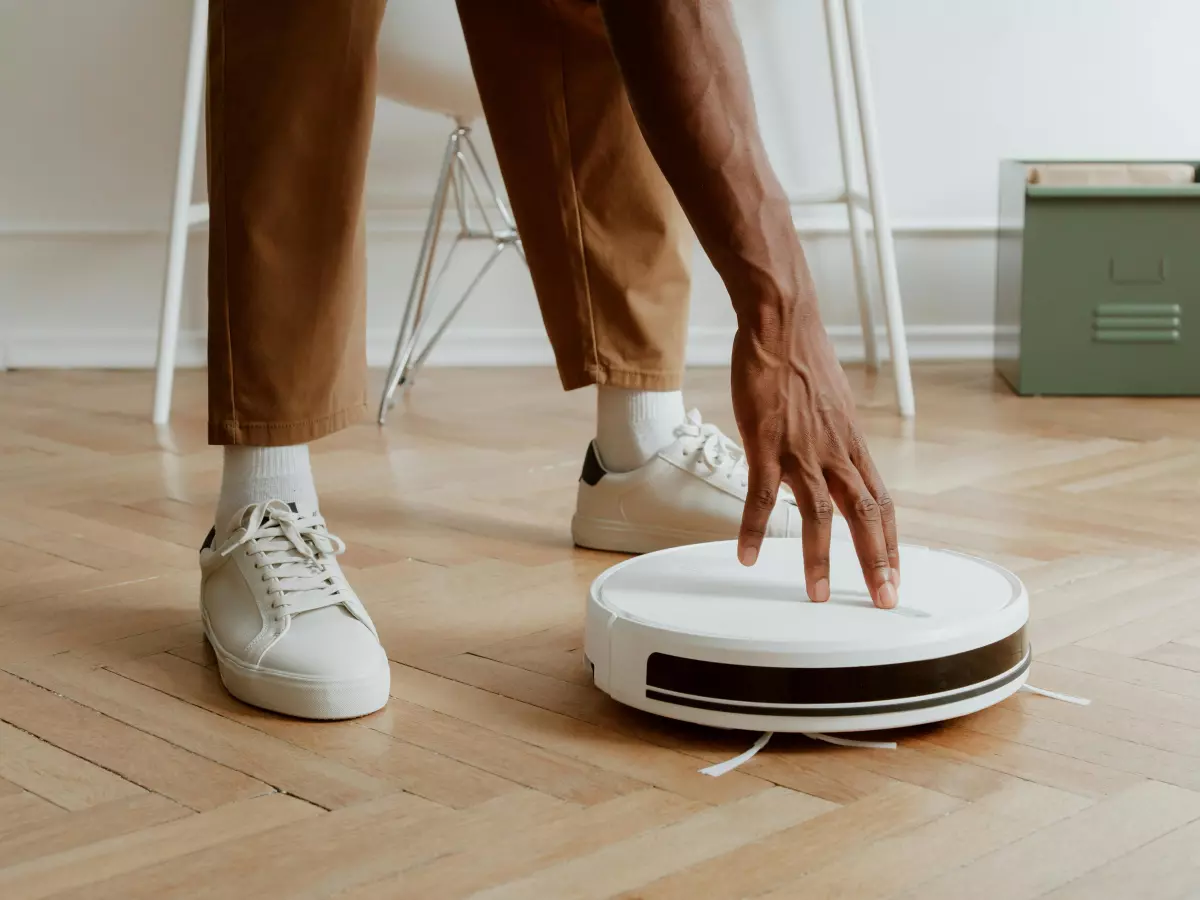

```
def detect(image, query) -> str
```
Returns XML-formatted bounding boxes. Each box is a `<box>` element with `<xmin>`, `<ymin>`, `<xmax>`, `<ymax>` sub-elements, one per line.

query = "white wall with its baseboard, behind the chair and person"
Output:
<box><xmin>0</xmin><ymin>0</ymin><xmax>1200</xmax><ymax>366</ymax></box>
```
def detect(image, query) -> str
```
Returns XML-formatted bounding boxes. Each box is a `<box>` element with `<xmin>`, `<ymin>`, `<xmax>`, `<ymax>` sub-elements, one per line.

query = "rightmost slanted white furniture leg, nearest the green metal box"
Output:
<box><xmin>838</xmin><ymin>0</ymin><xmax>917</xmax><ymax>419</ymax></box>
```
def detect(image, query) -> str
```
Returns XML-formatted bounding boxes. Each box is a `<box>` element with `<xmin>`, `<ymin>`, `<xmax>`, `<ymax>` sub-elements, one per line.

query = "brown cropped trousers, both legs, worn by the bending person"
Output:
<box><xmin>208</xmin><ymin>0</ymin><xmax>692</xmax><ymax>445</ymax></box>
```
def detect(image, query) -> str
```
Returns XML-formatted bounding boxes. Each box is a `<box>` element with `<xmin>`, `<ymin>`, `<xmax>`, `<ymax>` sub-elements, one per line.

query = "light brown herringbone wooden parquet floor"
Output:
<box><xmin>0</xmin><ymin>366</ymin><xmax>1200</xmax><ymax>900</ymax></box>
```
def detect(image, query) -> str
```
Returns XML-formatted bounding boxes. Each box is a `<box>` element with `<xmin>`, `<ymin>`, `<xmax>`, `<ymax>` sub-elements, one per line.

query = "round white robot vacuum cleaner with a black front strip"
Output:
<box><xmin>584</xmin><ymin>536</ymin><xmax>1031</xmax><ymax>733</ymax></box>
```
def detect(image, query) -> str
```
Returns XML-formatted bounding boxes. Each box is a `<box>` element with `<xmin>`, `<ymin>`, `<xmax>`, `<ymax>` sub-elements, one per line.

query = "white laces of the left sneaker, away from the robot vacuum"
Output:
<box><xmin>220</xmin><ymin>500</ymin><xmax>346</xmax><ymax>616</ymax></box>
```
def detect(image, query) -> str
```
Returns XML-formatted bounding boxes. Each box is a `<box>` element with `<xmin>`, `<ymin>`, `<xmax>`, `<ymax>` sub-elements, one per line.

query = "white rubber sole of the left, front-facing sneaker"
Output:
<box><xmin>204</xmin><ymin>619</ymin><xmax>391</xmax><ymax>720</ymax></box>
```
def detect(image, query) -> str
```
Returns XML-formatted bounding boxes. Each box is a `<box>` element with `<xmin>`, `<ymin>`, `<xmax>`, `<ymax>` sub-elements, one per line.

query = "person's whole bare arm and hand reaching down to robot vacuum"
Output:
<box><xmin>600</xmin><ymin>0</ymin><xmax>900</xmax><ymax>608</ymax></box>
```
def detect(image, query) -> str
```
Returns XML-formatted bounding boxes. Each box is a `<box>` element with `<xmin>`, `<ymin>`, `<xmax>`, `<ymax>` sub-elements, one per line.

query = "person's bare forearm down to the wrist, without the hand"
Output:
<box><xmin>600</xmin><ymin>0</ymin><xmax>815</xmax><ymax>348</ymax></box>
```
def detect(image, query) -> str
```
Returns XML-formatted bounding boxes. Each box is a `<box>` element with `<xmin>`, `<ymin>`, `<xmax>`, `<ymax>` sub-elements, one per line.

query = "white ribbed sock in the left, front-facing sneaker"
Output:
<box><xmin>216</xmin><ymin>444</ymin><xmax>317</xmax><ymax>532</ymax></box>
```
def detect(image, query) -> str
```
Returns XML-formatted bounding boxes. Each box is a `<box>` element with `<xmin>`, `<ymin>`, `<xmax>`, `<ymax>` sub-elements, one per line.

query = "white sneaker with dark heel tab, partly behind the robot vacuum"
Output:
<box><xmin>571</xmin><ymin>409</ymin><xmax>800</xmax><ymax>553</ymax></box>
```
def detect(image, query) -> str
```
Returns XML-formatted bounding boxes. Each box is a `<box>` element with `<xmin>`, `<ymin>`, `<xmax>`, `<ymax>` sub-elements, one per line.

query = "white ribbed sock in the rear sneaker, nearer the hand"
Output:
<box><xmin>596</xmin><ymin>386</ymin><xmax>688</xmax><ymax>472</ymax></box>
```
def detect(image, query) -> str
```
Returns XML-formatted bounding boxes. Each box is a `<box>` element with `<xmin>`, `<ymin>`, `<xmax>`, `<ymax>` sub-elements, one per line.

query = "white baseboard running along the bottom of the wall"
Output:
<box><xmin>0</xmin><ymin>325</ymin><xmax>1006</xmax><ymax>368</ymax></box>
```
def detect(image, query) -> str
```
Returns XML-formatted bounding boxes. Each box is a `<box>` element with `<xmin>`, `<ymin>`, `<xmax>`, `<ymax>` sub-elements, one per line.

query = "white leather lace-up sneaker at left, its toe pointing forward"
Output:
<box><xmin>200</xmin><ymin>500</ymin><xmax>391</xmax><ymax>719</ymax></box>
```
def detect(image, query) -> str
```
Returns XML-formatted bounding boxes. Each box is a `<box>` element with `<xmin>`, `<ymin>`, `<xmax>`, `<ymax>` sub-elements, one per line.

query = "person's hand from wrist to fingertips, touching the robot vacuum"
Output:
<box><xmin>732</xmin><ymin>306</ymin><xmax>900</xmax><ymax>610</ymax></box>
